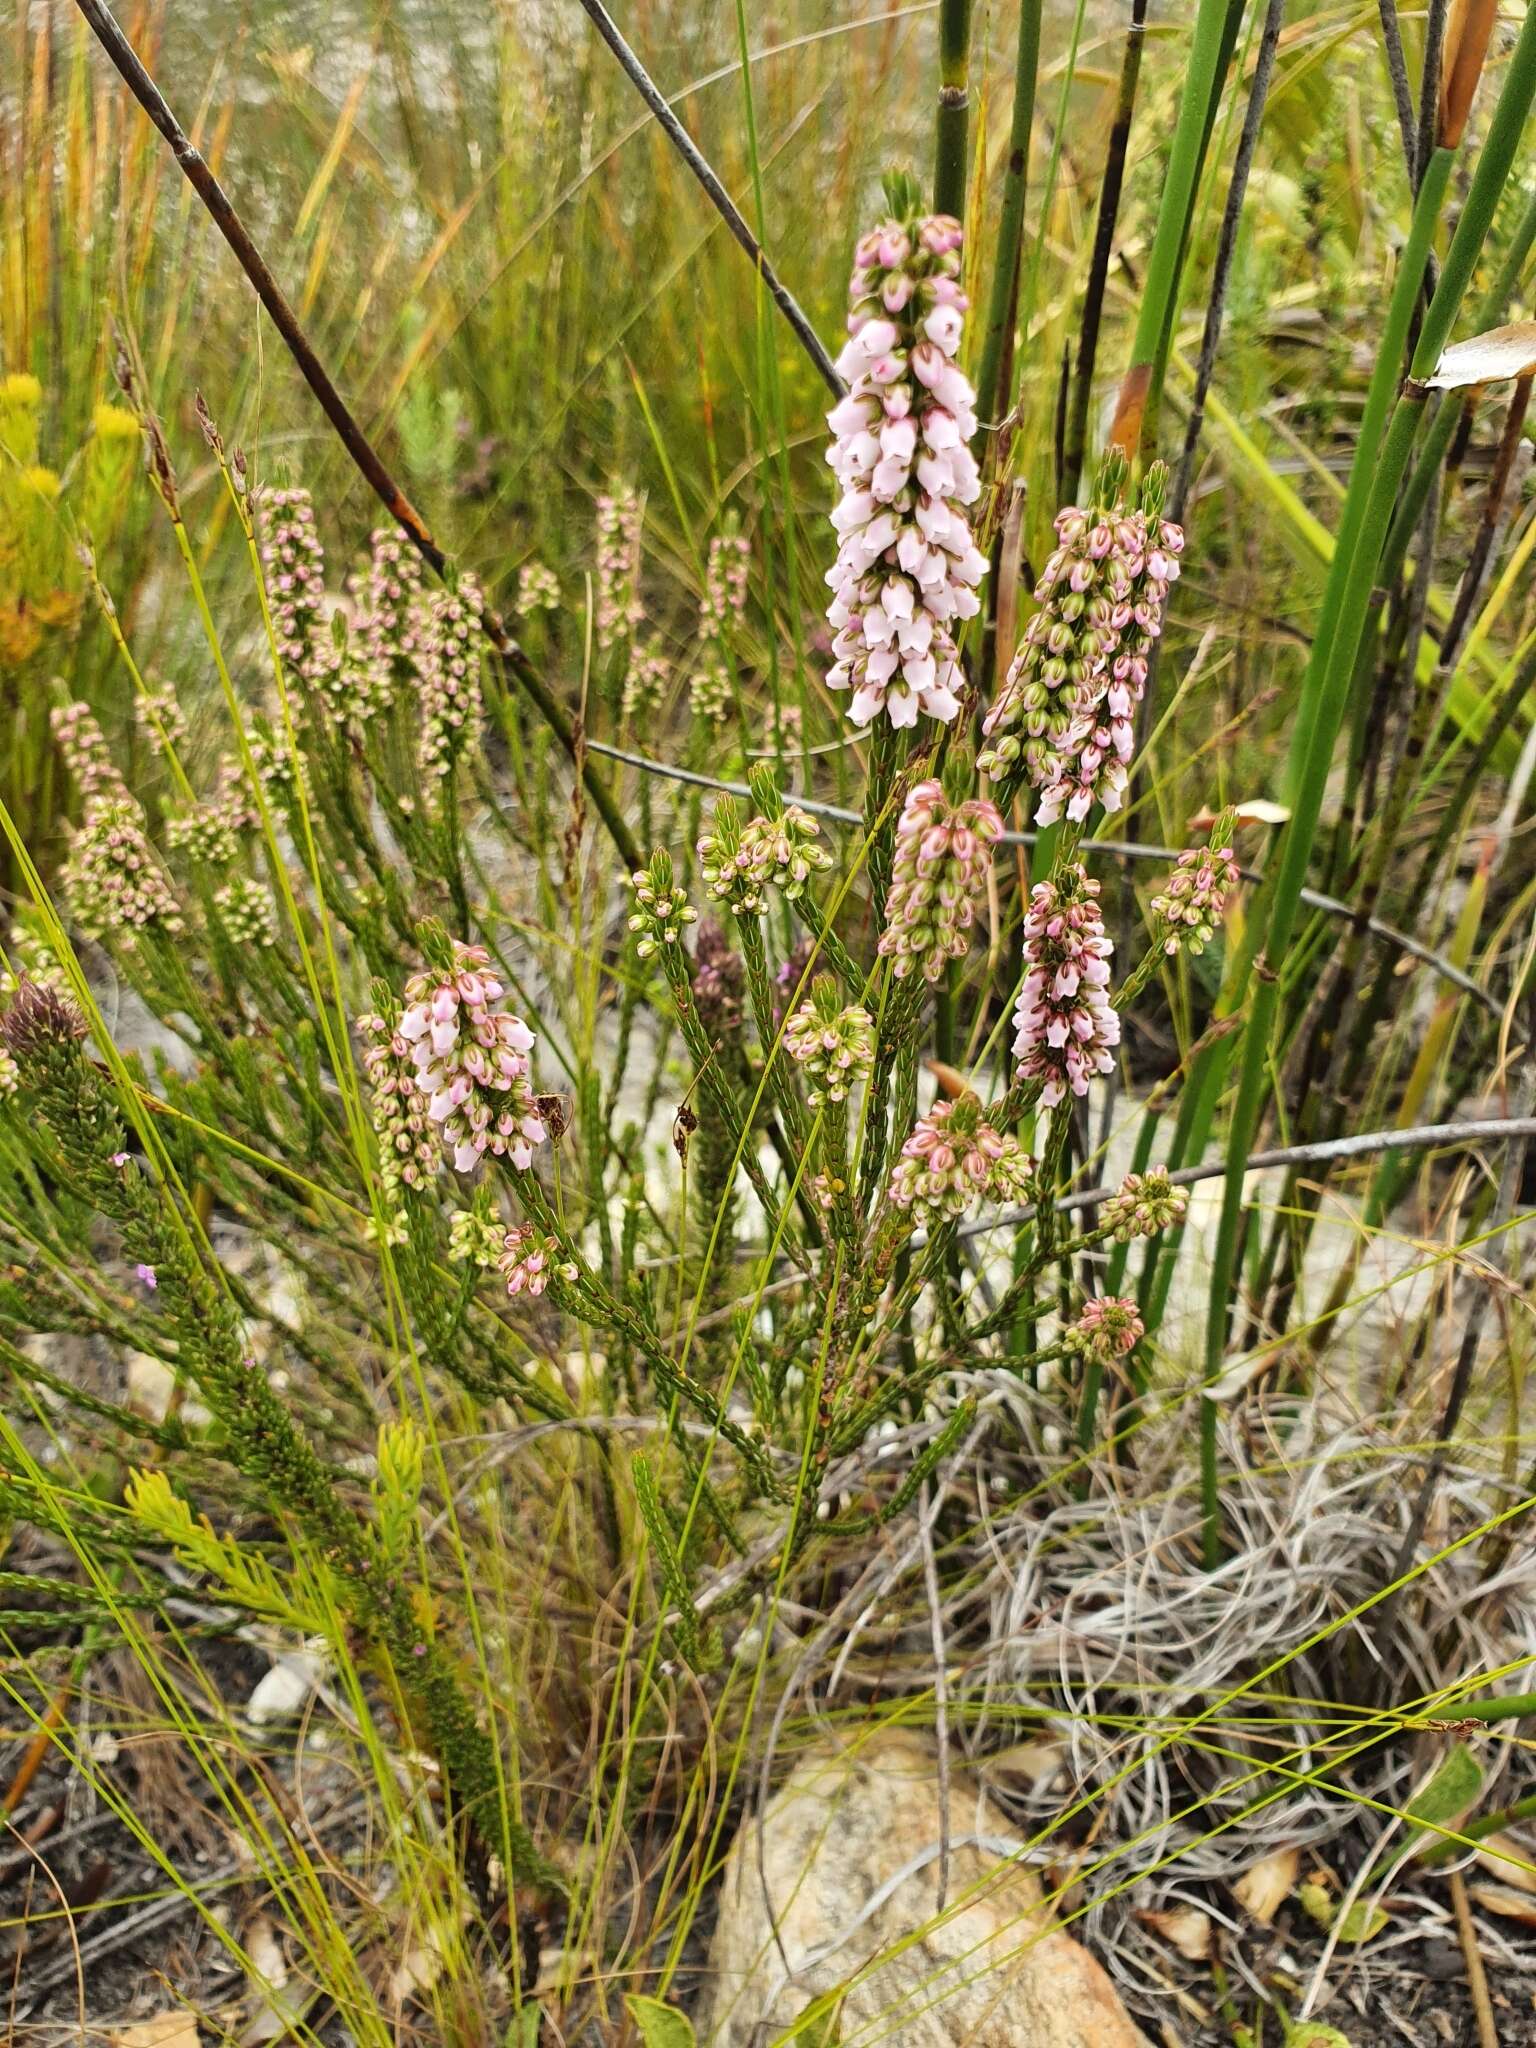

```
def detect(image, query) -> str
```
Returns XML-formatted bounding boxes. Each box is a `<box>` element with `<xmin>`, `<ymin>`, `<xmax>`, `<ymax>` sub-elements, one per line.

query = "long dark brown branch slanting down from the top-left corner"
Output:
<box><xmin>76</xmin><ymin>0</ymin><xmax>643</xmax><ymax>868</ymax></box>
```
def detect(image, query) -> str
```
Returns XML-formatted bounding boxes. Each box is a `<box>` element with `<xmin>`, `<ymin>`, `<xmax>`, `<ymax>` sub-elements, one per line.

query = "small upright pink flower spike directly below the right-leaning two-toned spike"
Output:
<box><xmin>1014</xmin><ymin>862</ymin><xmax>1120</xmax><ymax>1108</ymax></box>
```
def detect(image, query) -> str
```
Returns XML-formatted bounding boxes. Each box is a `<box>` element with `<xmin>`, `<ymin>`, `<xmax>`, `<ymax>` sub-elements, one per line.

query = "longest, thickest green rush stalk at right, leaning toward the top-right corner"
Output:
<box><xmin>1200</xmin><ymin>10</ymin><xmax>1536</xmax><ymax>1565</ymax></box>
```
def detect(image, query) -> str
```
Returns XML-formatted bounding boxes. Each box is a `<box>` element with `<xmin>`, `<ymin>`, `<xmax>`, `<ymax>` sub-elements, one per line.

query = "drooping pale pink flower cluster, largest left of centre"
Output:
<box><xmin>391</xmin><ymin>940</ymin><xmax>549</xmax><ymax>1174</ymax></box>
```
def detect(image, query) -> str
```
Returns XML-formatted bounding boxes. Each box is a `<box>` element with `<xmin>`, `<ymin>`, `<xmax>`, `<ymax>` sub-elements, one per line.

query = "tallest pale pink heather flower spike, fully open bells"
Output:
<box><xmin>827</xmin><ymin>215</ymin><xmax>987</xmax><ymax>727</ymax></box>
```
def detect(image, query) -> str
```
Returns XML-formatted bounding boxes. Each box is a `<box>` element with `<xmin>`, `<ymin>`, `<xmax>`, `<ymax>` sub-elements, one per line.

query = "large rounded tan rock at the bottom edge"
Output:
<box><xmin>698</xmin><ymin>1731</ymin><xmax>1147</xmax><ymax>2048</ymax></box>
